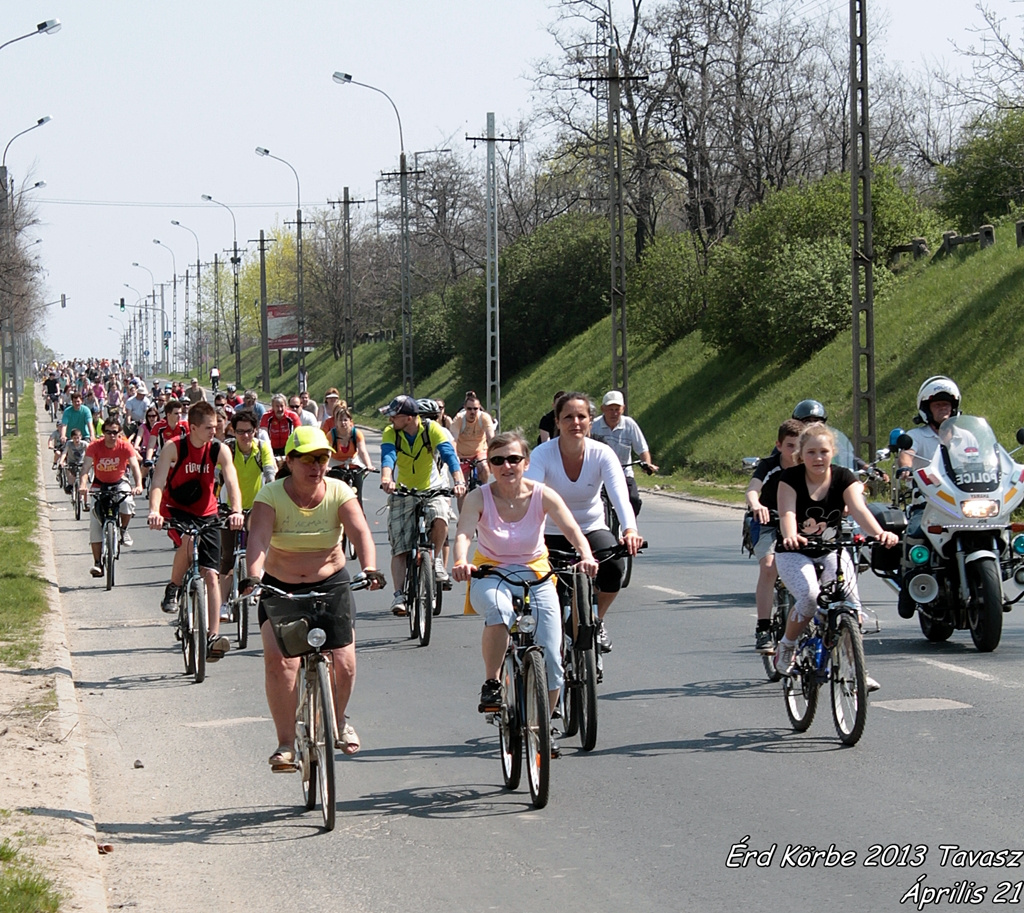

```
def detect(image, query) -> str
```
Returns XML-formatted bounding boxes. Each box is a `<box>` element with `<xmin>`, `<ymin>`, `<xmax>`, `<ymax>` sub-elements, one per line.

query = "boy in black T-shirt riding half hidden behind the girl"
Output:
<box><xmin>746</xmin><ymin>419</ymin><xmax>804</xmax><ymax>654</ymax></box>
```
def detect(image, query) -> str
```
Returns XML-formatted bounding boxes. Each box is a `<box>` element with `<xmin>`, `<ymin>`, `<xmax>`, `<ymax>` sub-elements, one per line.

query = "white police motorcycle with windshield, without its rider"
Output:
<box><xmin>869</xmin><ymin>415</ymin><xmax>1024</xmax><ymax>653</ymax></box>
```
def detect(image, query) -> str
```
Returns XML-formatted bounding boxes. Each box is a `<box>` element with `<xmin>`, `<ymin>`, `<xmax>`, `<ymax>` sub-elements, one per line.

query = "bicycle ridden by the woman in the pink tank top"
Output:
<box><xmin>472</xmin><ymin>565</ymin><xmax>555</xmax><ymax>809</ymax></box>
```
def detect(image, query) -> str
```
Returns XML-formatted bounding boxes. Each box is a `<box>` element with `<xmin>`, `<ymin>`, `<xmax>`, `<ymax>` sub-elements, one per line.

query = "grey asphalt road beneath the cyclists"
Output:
<box><xmin>47</xmin><ymin>423</ymin><xmax>1024</xmax><ymax>913</ymax></box>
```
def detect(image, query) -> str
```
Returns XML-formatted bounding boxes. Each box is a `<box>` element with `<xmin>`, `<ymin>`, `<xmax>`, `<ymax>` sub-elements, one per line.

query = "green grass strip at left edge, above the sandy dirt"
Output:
<box><xmin>0</xmin><ymin>386</ymin><xmax>48</xmax><ymax>663</ymax></box>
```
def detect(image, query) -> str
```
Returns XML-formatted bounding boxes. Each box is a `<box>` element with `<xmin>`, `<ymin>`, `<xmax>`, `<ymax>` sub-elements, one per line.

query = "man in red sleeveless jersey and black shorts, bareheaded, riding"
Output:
<box><xmin>148</xmin><ymin>402</ymin><xmax>244</xmax><ymax>662</ymax></box>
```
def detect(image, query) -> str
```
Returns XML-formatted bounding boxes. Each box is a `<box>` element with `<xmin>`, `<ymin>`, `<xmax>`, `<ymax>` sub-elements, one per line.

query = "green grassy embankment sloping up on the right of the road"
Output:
<box><xmin>222</xmin><ymin>223</ymin><xmax>1024</xmax><ymax>501</ymax></box>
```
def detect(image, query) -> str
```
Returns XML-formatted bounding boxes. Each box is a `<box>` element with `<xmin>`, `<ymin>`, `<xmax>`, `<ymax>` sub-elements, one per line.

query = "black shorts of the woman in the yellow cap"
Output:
<box><xmin>257</xmin><ymin>568</ymin><xmax>355</xmax><ymax>656</ymax></box>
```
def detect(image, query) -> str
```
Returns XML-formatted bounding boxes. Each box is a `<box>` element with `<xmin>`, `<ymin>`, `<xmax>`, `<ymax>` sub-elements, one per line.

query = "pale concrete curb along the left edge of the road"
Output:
<box><xmin>33</xmin><ymin>384</ymin><xmax>109</xmax><ymax>913</ymax></box>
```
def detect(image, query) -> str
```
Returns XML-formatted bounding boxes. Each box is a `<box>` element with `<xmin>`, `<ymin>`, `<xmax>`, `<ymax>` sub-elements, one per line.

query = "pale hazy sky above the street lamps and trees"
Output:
<box><xmin>0</xmin><ymin>0</ymin><xmax>1024</xmax><ymax>364</ymax></box>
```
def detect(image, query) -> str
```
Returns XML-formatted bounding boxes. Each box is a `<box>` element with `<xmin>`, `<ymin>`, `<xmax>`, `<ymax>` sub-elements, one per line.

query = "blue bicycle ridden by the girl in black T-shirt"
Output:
<box><xmin>782</xmin><ymin>534</ymin><xmax>872</xmax><ymax>745</ymax></box>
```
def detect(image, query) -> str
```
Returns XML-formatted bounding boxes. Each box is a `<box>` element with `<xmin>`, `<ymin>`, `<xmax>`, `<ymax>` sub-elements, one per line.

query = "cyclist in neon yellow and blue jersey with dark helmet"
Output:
<box><xmin>381</xmin><ymin>394</ymin><xmax>466</xmax><ymax>615</ymax></box>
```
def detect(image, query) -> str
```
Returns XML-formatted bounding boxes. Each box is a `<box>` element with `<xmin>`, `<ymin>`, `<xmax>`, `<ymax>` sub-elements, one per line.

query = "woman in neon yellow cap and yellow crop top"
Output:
<box><xmin>246</xmin><ymin>426</ymin><xmax>383</xmax><ymax>773</ymax></box>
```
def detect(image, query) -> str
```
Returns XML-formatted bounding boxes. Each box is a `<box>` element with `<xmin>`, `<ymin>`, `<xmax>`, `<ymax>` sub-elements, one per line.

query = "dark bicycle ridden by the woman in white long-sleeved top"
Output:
<box><xmin>548</xmin><ymin>541</ymin><xmax>647</xmax><ymax>751</ymax></box>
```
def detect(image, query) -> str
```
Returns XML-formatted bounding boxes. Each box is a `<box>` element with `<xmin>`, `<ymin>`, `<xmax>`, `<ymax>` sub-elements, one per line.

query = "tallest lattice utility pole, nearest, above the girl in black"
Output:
<box><xmin>850</xmin><ymin>0</ymin><xmax>877</xmax><ymax>463</ymax></box>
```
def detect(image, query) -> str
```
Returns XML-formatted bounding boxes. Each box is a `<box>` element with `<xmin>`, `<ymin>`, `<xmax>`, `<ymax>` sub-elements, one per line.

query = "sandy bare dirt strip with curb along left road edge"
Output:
<box><xmin>0</xmin><ymin>395</ymin><xmax>108</xmax><ymax>913</ymax></box>
